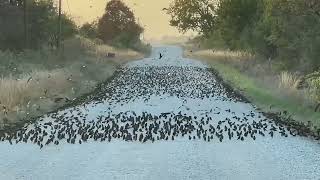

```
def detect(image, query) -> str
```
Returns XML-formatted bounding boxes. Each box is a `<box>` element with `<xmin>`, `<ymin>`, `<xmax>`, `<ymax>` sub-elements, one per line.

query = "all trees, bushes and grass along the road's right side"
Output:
<box><xmin>167</xmin><ymin>0</ymin><xmax>320</xmax><ymax>129</ymax></box>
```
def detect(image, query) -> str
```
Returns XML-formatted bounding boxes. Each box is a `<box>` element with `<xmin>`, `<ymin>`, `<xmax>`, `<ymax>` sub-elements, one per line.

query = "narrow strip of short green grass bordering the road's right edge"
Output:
<box><xmin>191</xmin><ymin>53</ymin><xmax>320</xmax><ymax>127</ymax></box>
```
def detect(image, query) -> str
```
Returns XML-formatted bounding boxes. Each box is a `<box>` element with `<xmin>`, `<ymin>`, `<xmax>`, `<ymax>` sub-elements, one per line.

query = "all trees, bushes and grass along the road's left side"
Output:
<box><xmin>0</xmin><ymin>0</ymin><xmax>150</xmax><ymax>129</ymax></box>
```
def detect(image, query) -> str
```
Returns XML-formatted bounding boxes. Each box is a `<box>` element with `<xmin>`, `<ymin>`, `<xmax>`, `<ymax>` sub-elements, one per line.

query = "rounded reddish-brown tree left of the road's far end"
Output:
<box><xmin>98</xmin><ymin>0</ymin><xmax>143</xmax><ymax>46</ymax></box>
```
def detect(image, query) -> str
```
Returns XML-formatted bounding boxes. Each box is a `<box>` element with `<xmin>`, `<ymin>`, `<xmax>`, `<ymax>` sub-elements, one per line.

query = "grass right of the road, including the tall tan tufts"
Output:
<box><xmin>185</xmin><ymin>47</ymin><xmax>320</xmax><ymax>127</ymax></box>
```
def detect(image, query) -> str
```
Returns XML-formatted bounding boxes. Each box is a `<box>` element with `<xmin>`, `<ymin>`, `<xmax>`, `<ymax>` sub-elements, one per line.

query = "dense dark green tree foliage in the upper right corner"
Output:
<box><xmin>252</xmin><ymin>0</ymin><xmax>320</xmax><ymax>70</ymax></box>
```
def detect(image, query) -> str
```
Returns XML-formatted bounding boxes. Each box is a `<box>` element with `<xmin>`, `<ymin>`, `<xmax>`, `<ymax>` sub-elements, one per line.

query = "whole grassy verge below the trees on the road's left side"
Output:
<box><xmin>0</xmin><ymin>37</ymin><xmax>144</xmax><ymax>129</ymax></box>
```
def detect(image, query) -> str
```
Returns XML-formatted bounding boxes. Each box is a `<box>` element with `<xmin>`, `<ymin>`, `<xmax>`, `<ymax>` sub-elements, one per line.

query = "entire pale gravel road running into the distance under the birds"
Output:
<box><xmin>0</xmin><ymin>46</ymin><xmax>320</xmax><ymax>180</ymax></box>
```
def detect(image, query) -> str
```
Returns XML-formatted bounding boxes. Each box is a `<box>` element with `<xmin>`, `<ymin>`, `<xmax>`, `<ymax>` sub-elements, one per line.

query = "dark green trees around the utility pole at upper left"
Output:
<box><xmin>0</xmin><ymin>0</ymin><xmax>77</xmax><ymax>50</ymax></box>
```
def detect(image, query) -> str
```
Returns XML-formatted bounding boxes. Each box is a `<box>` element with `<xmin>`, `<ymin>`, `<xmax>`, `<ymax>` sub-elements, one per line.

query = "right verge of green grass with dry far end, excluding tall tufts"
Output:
<box><xmin>185</xmin><ymin>46</ymin><xmax>320</xmax><ymax>134</ymax></box>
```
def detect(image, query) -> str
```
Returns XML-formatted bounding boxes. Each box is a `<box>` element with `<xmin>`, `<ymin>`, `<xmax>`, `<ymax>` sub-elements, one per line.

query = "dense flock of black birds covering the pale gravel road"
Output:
<box><xmin>0</xmin><ymin>48</ymin><xmax>297</xmax><ymax>148</ymax></box>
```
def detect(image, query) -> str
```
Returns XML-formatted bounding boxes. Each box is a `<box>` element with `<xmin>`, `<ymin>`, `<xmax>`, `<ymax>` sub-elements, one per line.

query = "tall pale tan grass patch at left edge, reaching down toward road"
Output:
<box><xmin>0</xmin><ymin>69</ymin><xmax>73</xmax><ymax>122</ymax></box>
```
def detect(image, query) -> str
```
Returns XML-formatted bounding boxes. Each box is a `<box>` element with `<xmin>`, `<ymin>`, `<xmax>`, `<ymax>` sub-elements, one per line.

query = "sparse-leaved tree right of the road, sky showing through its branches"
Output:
<box><xmin>167</xmin><ymin>0</ymin><xmax>217</xmax><ymax>36</ymax></box>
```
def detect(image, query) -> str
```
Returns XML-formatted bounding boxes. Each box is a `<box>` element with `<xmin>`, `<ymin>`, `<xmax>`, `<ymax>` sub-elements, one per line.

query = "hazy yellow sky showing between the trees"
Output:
<box><xmin>63</xmin><ymin>0</ymin><xmax>194</xmax><ymax>39</ymax></box>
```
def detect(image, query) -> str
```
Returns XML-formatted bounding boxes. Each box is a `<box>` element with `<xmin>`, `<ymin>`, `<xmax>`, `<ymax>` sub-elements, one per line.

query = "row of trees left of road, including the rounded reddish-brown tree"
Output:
<box><xmin>0</xmin><ymin>0</ymin><xmax>143</xmax><ymax>51</ymax></box>
